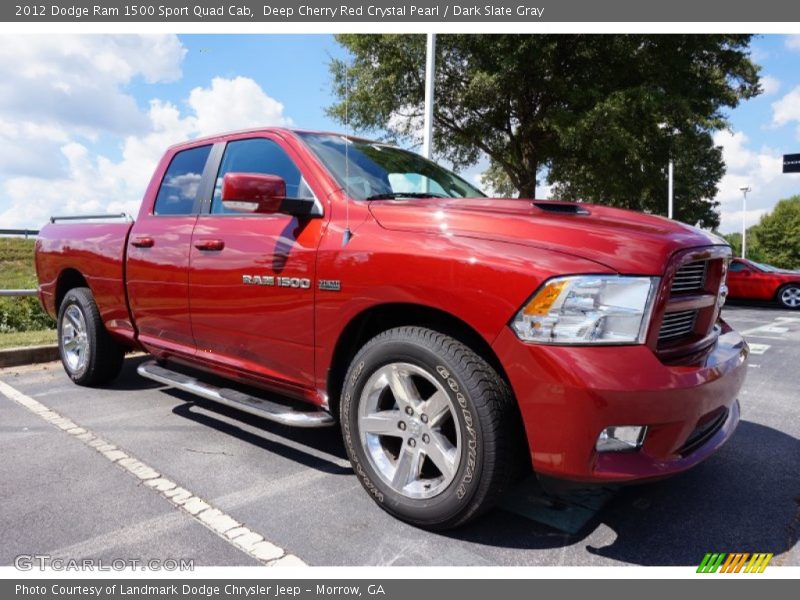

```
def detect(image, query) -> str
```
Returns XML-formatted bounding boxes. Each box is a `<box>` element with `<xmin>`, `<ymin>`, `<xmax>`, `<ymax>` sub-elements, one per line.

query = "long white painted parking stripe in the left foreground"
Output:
<box><xmin>0</xmin><ymin>381</ymin><xmax>305</xmax><ymax>566</ymax></box>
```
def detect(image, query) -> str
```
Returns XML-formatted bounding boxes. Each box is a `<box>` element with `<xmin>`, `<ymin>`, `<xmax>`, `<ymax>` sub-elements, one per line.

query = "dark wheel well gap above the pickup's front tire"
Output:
<box><xmin>327</xmin><ymin>303</ymin><xmax>508</xmax><ymax>415</ymax></box>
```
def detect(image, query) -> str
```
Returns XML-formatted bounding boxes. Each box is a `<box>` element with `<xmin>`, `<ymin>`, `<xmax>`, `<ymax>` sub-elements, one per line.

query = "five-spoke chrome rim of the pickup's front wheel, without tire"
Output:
<box><xmin>358</xmin><ymin>363</ymin><xmax>461</xmax><ymax>499</ymax></box>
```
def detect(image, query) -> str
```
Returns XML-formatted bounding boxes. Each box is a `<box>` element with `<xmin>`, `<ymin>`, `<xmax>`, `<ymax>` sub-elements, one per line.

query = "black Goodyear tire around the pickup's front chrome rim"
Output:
<box><xmin>340</xmin><ymin>327</ymin><xmax>522</xmax><ymax>530</ymax></box>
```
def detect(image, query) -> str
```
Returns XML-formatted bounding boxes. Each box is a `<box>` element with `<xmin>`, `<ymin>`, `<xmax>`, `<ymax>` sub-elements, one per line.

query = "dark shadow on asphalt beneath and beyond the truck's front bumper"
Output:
<box><xmin>450</xmin><ymin>421</ymin><xmax>800</xmax><ymax>566</ymax></box>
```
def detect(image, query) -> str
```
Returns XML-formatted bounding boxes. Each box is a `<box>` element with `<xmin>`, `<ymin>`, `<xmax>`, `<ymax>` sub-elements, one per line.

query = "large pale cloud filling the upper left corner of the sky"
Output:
<box><xmin>0</xmin><ymin>35</ymin><xmax>185</xmax><ymax>183</ymax></box>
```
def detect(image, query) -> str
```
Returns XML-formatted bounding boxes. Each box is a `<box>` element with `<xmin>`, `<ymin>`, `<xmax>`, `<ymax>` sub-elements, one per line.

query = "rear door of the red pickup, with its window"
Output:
<box><xmin>126</xmin><ymin>145</ymin><xmax>212</xmax><ymax>355</ymax></box>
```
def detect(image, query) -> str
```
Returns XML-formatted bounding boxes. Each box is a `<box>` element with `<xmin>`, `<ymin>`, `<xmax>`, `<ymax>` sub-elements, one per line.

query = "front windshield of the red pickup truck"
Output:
<box><xmin>298</xmin><ymin>133</ymin><xmax>485</xmax><ymax>200</ymax></box>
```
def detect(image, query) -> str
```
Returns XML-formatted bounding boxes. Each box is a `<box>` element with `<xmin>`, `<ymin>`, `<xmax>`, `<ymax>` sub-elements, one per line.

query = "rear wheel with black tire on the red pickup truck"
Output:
<box><xmin>58</xmin><ymin>287</ymin><xmax>125</xmax><ymax>387</ymax></box>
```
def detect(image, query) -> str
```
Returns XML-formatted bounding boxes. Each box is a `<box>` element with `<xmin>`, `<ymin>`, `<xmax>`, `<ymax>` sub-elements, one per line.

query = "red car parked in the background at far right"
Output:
<box><xmin>728</xmin><ymin>258</ymin><xmax>800</xmax><ymax>310</ymax></box>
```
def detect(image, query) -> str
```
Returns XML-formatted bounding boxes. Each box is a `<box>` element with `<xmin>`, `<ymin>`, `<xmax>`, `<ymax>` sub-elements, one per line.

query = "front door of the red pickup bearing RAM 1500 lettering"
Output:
<box><xmin>189</xmin><ymin>134</ymin><xmax>325</xmax><ymax>395</ymax></box>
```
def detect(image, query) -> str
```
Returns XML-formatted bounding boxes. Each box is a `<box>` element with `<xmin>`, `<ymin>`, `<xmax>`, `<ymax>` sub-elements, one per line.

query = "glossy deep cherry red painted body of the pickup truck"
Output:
<box><xmin>37</xmin><ymin>129</ymin><xmax>747</xmax><ymax>481</ymax></box>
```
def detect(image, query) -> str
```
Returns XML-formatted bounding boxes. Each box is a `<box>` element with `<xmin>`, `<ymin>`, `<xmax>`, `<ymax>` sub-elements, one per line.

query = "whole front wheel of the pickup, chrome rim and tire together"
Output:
<box><xmin>340</xmin><ymin>327</ymin><xmax>519</xmax><ymax>529</ymax></box>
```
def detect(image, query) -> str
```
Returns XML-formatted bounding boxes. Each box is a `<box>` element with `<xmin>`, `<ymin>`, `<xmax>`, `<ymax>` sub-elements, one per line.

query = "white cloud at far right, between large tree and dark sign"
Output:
<box><xmin>714</xmin><ymin>131</ymin><xmax>800</xmax><ymax>233</ymax></box>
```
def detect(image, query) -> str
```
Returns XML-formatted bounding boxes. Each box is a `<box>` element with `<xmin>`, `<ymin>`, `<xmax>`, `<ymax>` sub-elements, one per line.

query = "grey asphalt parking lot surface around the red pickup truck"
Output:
<box><xmin>0</xmin><ymin>306</ymin><xmax>800</xmax><ymax>566</ymax></box>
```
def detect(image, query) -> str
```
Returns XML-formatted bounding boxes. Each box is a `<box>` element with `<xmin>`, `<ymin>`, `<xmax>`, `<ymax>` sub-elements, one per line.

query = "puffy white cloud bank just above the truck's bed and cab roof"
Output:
<box><xmin>0</xmin><ymin>77</ymin><xmax>291</xmax><ymax>227</ymax></box>
